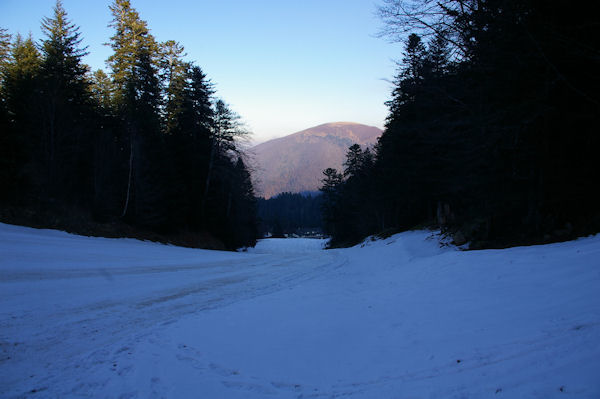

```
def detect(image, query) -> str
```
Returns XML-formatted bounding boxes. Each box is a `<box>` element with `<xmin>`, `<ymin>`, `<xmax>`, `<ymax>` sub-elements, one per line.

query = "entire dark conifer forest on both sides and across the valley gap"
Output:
<box><xmin>0</xmin><ymin>0</ymin><xmax>600</xmax><ymax>248</ymax></box>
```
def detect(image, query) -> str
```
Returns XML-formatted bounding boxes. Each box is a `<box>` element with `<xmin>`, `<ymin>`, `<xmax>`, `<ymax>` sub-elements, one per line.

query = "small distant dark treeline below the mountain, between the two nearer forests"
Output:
<box><xmin>258</xmin><ymin>193</ymin><xmax>323</xmax><ymax>237</ymax></box>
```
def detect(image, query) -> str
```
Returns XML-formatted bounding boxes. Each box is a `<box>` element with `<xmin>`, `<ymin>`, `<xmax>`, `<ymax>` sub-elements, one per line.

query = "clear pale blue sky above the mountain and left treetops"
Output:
<box><xmin>0</xmin><ymin>0</ymin><xmax>402</xmax><ymax>143</ymax></box>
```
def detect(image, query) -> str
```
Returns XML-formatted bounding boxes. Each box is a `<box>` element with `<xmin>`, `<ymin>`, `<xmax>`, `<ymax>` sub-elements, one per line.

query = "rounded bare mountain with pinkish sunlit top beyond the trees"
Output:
<box><xmin>250</xmin><ymin>122</ymin><xmax>381</xmax><ymax>198</ymax></box>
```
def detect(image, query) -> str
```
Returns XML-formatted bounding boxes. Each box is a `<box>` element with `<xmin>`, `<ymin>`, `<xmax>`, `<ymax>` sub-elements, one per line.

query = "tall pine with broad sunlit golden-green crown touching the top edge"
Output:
<box><xmin>107</xmin><ymin>0</ymin><xmax>164</xmax><ymax>225</ymax></box>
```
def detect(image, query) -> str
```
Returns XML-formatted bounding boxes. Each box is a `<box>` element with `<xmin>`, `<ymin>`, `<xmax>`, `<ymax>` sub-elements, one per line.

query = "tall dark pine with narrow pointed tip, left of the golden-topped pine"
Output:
<box><xmin>41</xmin><ymin>0</ymin><xmax>91</xmax><ymax>205</ymax></box>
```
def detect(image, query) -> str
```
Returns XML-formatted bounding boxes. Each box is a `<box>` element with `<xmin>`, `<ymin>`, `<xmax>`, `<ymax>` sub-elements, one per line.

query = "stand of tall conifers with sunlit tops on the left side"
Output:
<box><xmin>0</xmin><ymin>0</ymin><xmax>257</xmax><ymax>248</ymax></box>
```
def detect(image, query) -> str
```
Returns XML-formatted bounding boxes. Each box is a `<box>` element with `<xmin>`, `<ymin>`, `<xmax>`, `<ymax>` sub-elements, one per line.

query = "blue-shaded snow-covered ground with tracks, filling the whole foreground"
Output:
<box><xmin>0</xmin><ymin>224</ymin><xmax>600</xmax><ymax>399</ymax></box>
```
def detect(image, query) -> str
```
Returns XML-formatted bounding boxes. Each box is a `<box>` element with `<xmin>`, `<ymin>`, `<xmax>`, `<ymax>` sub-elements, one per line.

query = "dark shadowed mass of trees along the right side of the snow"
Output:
<box><xmin>322</xmin><ymin>0</ymin><xmax>600</xmax><ymax>248</ymax></box>
